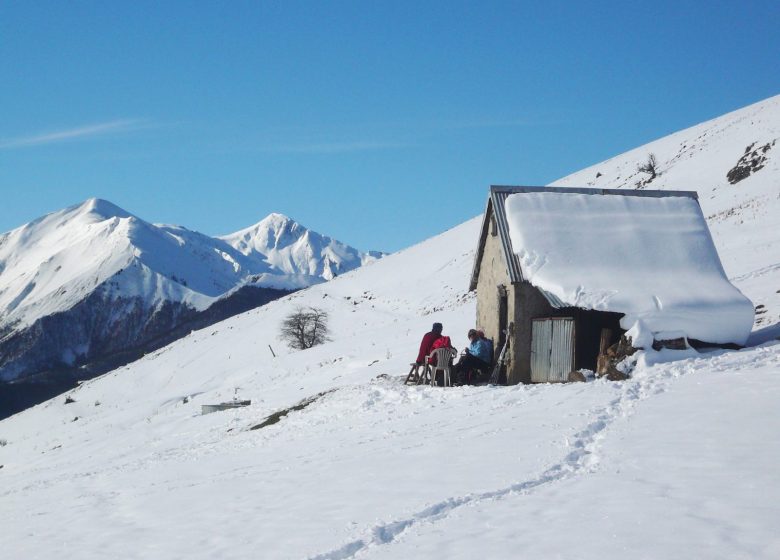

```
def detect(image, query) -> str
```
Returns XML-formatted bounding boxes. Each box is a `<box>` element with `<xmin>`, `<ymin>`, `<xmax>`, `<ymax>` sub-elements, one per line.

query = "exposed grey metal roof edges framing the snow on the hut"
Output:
<box><xmin>469</xmin><ymin>186</ymin><xmax>699</xmax><ymax>308</ymax></box>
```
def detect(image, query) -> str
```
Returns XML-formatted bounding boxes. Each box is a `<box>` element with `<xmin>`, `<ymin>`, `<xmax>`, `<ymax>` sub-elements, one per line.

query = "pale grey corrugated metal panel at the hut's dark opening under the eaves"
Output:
<box><xmin>531</xmin><ymin>317</ymin><xmax>574</xmax><ymax>383</ymax></box>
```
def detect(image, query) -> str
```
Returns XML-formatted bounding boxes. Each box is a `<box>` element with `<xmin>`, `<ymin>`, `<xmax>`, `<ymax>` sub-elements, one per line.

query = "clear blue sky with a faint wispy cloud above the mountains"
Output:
<box><xmin>0</xmin><ymin>0</ymin><xmax>780</xmax><ymax>251</ymax></box>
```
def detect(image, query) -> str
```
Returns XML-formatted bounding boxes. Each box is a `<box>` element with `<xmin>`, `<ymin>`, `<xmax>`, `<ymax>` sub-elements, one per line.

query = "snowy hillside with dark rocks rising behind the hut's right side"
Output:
<box><xmin>553</xmin><ymin>95</ymin><xmax>780</xmax><ymax>326</ymax></box>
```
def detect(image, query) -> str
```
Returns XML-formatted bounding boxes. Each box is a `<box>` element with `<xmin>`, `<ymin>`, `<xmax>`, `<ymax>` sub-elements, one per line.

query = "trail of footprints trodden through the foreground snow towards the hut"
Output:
<box><xmin>309</xmin><ymin>349</ymin><xmax>774</xmax><ymax>560</ymax></box>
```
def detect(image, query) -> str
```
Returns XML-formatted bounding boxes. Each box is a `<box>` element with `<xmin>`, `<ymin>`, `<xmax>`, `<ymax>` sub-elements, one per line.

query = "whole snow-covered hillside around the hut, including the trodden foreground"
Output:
<box><xmin>0</xmin><ymin>94</ymin><xmax>780</xmax><ymax>560</ymax></box>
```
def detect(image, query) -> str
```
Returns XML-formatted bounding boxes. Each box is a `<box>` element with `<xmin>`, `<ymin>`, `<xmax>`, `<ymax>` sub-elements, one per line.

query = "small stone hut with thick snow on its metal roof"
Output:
<box><xmin>470</xmin><ymin>187</ymin><xmax>754</xmax><ymax>384</ymax></box>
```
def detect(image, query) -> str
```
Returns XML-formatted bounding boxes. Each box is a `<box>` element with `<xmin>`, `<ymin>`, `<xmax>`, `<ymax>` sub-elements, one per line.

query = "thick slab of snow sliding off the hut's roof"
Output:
<box><xmin>505</xmin><ymin>192</ymin><xmax>753</xmax><ymax>344</ymax></box>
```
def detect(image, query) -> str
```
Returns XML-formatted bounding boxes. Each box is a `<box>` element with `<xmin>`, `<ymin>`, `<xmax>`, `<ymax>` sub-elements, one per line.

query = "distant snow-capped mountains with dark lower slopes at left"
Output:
<box><xmin>0</xmin><ymin>199</ymin><xmax>381</xmax><ymax>388</ymax></box>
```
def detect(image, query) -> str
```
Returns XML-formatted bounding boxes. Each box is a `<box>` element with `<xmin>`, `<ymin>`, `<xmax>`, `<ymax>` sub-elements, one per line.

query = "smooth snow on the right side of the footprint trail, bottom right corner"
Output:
<box><xmin>365</xmin><ymin>346</ymin><xmax>780</xmax><ymax>559</ymax></box>
